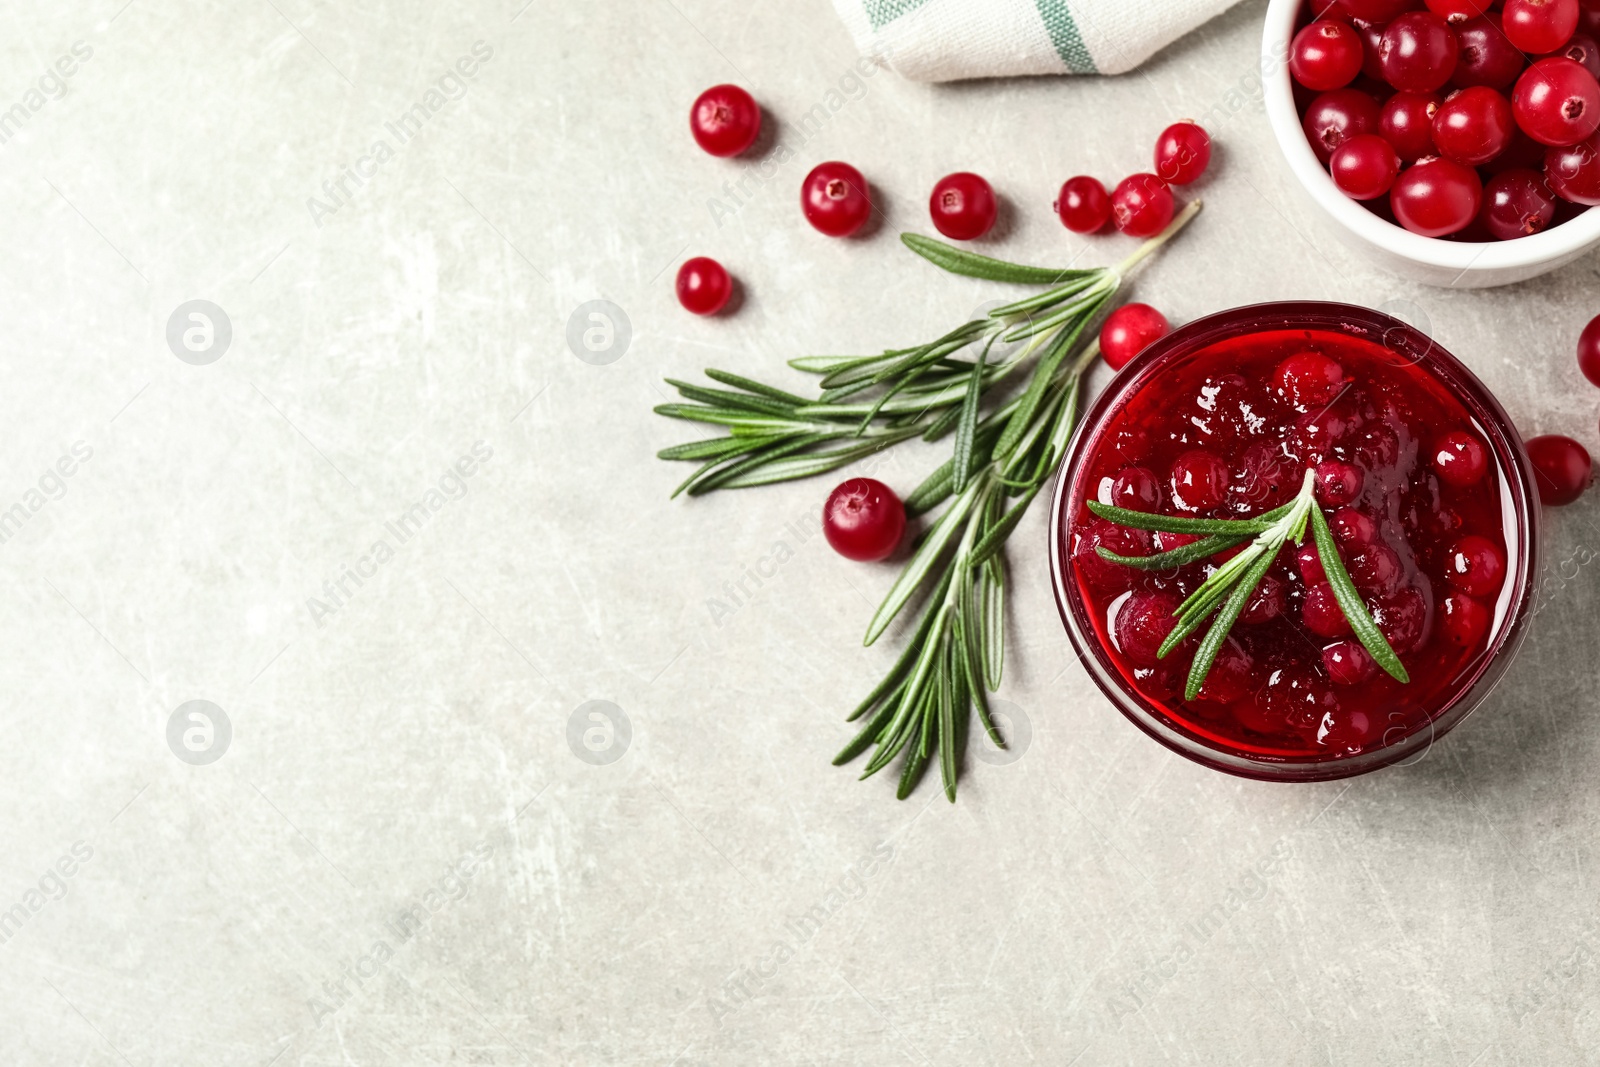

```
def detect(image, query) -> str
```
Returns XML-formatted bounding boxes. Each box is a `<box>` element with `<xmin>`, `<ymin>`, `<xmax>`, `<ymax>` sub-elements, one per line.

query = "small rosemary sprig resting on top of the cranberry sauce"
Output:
<box><xmin>1088</xmin><ymin>470</ymin><xmax>1411</xmax><ymax>701</ymax></box>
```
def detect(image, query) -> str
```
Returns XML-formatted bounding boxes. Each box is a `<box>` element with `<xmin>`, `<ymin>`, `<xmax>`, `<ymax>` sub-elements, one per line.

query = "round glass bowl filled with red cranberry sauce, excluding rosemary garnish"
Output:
<box><xmin>1050</xmin><ymin>302</ymin><xmax>1539</xmax><ymax>781</ymax></box>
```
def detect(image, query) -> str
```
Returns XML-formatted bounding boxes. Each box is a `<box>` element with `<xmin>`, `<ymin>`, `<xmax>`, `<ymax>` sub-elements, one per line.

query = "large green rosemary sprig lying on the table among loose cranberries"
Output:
<box><xmin>656</xmin><ymin>202</ymin><xmax>1200</xmax><ymax>801</ymax></box>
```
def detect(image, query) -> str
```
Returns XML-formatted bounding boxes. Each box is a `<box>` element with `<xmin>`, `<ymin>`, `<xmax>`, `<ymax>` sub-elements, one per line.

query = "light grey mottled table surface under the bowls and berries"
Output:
<box><xmin>0</xmin><ymin>0</ymin><xmax>1600</xmax><ymax>1067</ymax></box>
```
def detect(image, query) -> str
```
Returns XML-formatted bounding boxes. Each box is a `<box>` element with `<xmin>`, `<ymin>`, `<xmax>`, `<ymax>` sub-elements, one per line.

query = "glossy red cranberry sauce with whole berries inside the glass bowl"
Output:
<box><xmin>1064</xmin><ymin>330</ymin><xmax>1507</xmax><ymax>761</ymax></box>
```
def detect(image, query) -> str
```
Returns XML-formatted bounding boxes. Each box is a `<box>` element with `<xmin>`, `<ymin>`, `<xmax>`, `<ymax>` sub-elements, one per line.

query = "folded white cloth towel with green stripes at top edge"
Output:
<box><xmin>834</xmin><ymin>0</ymin><xmax>1237</xmax><ymax>82</ymax></box>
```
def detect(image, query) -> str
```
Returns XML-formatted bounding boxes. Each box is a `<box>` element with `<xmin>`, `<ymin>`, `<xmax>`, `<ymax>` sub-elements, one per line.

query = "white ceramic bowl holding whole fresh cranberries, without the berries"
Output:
<box><xmin>1261</xmin><ymin>0</ymin><xmax>1600</xmax><ymax>290</ymax></box>
